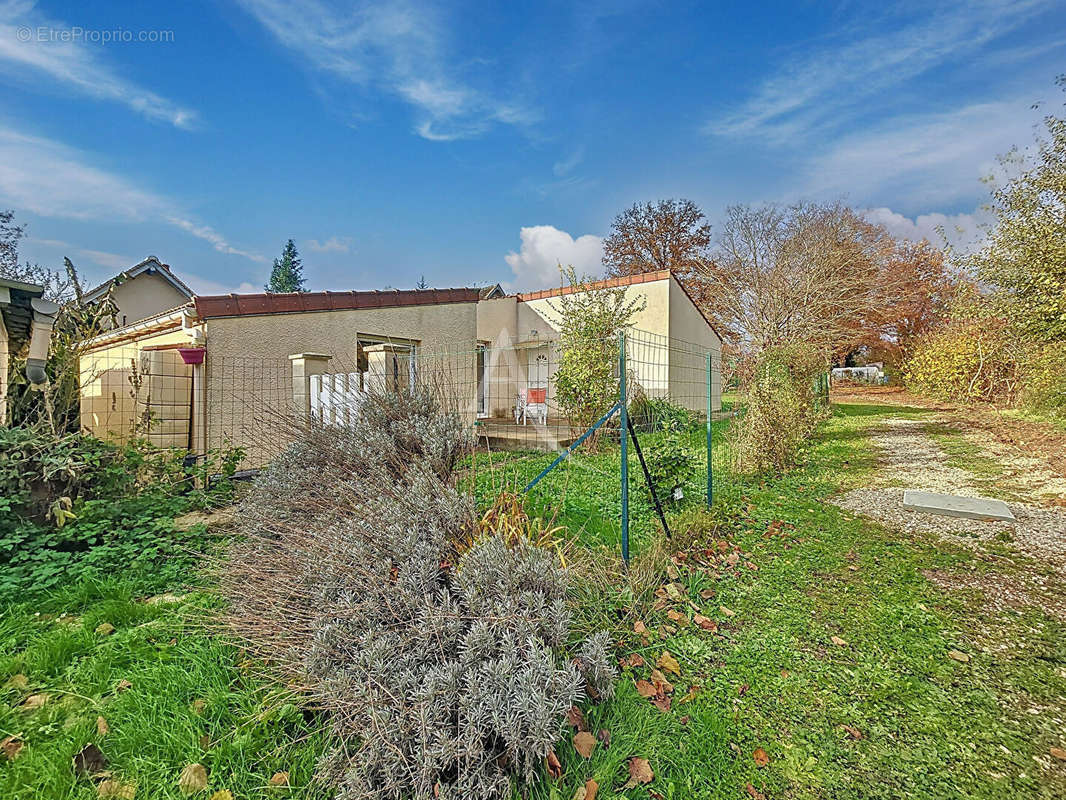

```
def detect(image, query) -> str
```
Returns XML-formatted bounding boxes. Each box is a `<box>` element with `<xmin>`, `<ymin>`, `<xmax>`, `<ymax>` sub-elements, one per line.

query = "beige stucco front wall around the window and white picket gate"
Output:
<box><xmin>205</xmin><ymin>303</ymin><xmax>478</xmax><ymax>466</ymax></box>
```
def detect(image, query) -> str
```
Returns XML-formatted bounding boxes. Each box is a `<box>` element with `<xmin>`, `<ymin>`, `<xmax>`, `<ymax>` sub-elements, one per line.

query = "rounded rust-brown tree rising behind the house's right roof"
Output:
<box><xmin>603</xmin><ymin>199</ymin><xmax>711</xmax><ymax>279</ymax></box>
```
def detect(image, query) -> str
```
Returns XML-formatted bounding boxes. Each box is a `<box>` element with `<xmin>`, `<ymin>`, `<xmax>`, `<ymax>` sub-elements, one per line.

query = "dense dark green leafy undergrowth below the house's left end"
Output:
<box><xmin>0</xmin><ymin>428</ymin><xmax>240</xmax><ymax>598</ymax></box>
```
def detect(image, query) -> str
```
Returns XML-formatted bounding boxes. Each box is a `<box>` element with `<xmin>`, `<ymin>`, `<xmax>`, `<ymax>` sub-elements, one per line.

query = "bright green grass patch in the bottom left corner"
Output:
<box><xmin>0</xmin><ymin>579</ymin><xmax>323</xmax><ymax>800</ymax></box>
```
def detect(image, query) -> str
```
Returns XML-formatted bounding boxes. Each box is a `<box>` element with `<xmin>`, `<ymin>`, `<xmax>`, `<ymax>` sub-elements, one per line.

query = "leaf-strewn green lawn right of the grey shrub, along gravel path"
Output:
<box><xmin>478</xmin><ymin>405</ymin><xmax>1066</xmax><ymax>798</ymax></box>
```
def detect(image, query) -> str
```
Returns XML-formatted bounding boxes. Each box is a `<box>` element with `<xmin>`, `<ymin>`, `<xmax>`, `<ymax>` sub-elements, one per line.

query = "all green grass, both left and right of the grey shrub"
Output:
<box><xmin>0</xmin><ymin>405</ymin><xmax>1066</xmax><ymax>800</ymax></box>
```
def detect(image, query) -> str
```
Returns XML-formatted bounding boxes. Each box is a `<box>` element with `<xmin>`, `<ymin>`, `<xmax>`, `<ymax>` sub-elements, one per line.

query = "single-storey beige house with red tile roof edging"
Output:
<box><xmin>82</xmin><ymin>272</ymin><xmax>722</xmax><ymax>465</ymax></box>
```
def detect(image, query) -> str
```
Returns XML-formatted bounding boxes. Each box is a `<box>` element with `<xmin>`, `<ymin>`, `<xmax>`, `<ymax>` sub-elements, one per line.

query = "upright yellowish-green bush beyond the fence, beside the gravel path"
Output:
<box><xmin>732</xmin><ymin>345</ymin><xmax>827</xmax><ymax>473</ymax></box>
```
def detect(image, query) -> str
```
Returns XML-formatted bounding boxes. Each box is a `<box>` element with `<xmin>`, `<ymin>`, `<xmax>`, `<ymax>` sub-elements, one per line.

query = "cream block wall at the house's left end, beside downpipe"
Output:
<box><xmin>80</xmin><ymin>329</ymin><xmax>192</xmax><ymax>447</ymax></box>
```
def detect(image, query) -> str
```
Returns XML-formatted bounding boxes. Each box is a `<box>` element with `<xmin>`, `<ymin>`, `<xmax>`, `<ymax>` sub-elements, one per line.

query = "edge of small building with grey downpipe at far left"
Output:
<box><xmin>0</xmin><ymin>278</ymin><xmax>59</xmax><ymax>425</ymax></box>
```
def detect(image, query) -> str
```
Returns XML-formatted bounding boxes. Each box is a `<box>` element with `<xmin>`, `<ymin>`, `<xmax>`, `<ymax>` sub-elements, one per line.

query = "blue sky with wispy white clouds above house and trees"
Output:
<box><xmin>0</xmin><ymin>0</ymin><xmax>1066</xmax><ymax>293</ymax></box>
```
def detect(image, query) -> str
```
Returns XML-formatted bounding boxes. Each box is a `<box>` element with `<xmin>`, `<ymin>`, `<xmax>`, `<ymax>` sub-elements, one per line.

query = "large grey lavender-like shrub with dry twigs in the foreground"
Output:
<box><xmin>220</xmin><ymin>394</ymin><xmax>614</xmax><ymax>800</ymax></box>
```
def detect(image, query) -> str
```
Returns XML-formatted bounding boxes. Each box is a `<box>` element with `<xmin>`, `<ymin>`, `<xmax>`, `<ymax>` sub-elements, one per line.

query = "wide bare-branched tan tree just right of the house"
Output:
<box><xmin>696</xmin><ymin>203</ymin><xmax>893</xmax><ymax>358</ymax></box>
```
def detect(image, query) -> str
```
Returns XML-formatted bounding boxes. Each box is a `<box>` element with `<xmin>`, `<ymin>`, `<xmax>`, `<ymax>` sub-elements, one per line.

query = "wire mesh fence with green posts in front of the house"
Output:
<box><xmin>81</xmin><ymin>330</ymin><xmax>729</xmax><ymax>558</ymax></box>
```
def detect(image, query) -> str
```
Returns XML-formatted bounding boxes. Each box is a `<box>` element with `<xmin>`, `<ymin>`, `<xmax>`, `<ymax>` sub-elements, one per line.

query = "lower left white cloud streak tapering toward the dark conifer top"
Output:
<box><xmin>0</xmin><ymin>126</ymin><xmax>267</xmax><ymax>261</ymax></box>
